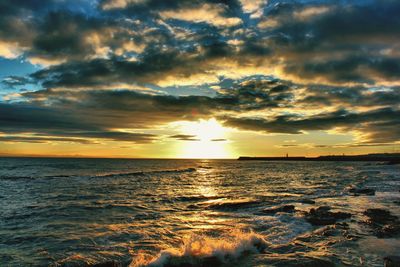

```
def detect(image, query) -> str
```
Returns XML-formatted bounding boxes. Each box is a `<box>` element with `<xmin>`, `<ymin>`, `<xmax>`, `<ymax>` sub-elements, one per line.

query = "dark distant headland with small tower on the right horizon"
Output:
<box><xmin>238</xmin><ymin>153</ymin><xmax>400</xmax><ymax>164</ymax></box>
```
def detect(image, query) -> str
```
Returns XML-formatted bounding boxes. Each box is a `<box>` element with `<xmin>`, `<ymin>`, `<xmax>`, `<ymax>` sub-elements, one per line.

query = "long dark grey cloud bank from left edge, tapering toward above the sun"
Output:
<box><xmin>0</xmin><ymin>91</ymin><xmax>219</xmax><ymax>143</ymax></box>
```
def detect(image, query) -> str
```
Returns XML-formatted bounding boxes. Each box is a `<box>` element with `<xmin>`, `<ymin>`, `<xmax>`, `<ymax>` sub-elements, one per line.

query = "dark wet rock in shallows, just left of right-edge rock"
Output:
<box><xmin>305</xmin><ymin>206</ymin><xmax>351</xmax><ymax>225</ymax></box>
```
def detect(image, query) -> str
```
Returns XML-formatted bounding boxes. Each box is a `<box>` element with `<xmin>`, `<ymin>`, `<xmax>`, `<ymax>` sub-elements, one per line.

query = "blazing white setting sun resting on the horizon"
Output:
<box><xmin>173</xmin><ymin>119</ymin><xmax>232</xmax><ymax>159</ymax></box>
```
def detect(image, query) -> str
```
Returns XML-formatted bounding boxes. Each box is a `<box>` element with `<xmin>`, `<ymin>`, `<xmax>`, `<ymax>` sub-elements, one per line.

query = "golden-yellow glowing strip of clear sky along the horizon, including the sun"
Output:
<box><xmin>0</xmin><ymin>118</ymin><xmax>399</xmax><ymax>159</ymax></box>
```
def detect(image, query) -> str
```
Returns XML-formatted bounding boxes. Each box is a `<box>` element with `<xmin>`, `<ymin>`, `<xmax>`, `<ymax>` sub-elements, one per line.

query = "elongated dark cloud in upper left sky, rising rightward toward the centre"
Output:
<box><xmin>31</xmin><ymin>41</ymin><xmax>268</xmax><ymax>88</ymax></box>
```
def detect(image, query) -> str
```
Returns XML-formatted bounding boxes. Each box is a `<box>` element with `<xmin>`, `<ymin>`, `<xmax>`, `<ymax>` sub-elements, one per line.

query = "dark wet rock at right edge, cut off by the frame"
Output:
<box><xmin>364</xmin><ymin>209</ymin><xmax>400</xmax><ymax>238</ymax></box>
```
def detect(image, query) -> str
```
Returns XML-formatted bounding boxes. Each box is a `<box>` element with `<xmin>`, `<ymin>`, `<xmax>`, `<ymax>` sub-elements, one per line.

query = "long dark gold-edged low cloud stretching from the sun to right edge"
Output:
<box><xmin>221</xmin><ymin>108</ymin><xmax>400</xmax><ymax>142</ymax></box>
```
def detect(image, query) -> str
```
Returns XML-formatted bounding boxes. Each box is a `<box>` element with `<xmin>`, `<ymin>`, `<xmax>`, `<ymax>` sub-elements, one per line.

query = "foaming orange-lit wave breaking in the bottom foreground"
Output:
<box><xmin>130</xmin><ymin>230</ymin><xmax>270</xmax><ymax>267</ymax></box>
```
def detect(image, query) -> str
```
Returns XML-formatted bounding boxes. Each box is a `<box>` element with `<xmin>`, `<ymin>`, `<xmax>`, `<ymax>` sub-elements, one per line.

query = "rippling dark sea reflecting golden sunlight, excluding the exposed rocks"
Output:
<box><xmin>0</xmin><ymin>158</ymin><xmax>400</xmax><ymax>266</ymax></box>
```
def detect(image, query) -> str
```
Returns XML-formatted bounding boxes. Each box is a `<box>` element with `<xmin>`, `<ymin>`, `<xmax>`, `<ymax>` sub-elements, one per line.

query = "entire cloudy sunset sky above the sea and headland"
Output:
<box><xmin>0</xmin><ymin>0</ymin><xmax>400</xmax><ymax>158</ymax></box>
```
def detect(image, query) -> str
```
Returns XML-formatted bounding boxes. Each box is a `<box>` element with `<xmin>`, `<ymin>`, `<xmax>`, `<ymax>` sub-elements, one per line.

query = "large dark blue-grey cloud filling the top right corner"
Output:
<box><xmin>268</xmin><ymin>1</ymin><xmax>400</xmax><ymax>84</ymax></box>
